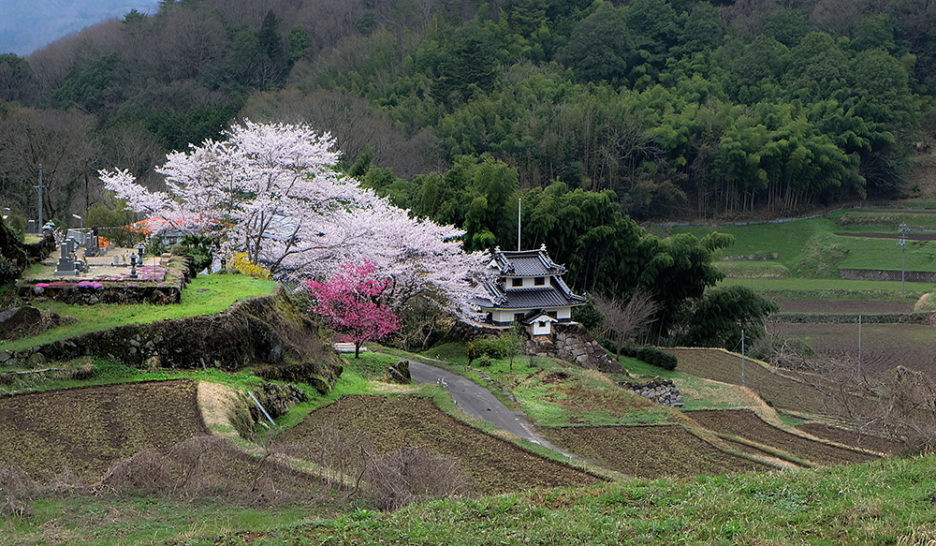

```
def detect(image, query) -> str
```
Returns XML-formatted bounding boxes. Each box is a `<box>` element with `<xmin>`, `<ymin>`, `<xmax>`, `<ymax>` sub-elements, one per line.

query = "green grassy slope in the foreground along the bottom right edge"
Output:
<box><xmin>232</xmin><ymin>455</ymin><xmax>936</xmax><ymax>544</ymax></box>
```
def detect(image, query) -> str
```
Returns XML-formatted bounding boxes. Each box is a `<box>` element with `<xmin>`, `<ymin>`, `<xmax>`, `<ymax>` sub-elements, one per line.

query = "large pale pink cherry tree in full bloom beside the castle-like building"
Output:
<box><xmin>100</xmin><ymin>120</ymin><xmax>485</xmax><ymax>316</ymax></box>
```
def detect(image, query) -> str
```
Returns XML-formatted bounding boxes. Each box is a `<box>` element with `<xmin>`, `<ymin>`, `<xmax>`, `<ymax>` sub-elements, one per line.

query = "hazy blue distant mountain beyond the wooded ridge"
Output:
<box><xmin>0</xmin><ymin>0</ymin><xmax>159</xmax><ymax>55</ymax></box>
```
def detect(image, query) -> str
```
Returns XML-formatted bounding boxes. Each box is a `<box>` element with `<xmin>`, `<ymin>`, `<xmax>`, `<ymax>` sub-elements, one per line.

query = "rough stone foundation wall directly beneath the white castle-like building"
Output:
<box><xmin>524</xmin><ymin>322</ymin><xmax>625</xmax><ymax>373</ymax></box>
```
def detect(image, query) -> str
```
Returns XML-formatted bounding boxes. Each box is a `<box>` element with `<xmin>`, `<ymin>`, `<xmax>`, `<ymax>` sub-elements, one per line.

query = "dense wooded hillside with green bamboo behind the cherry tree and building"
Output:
<box><xmin>0</xmin><ymin>0</ymin><xmax>936</xmax><ymax>314</ymax></box>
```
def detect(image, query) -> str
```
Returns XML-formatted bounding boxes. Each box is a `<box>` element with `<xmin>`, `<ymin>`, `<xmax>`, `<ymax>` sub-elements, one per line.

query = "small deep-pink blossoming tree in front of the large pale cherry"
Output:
<box><xmin>306</xmin><ymin>260</ymin><xmax>399</xmax><ymax>358</ymax></box>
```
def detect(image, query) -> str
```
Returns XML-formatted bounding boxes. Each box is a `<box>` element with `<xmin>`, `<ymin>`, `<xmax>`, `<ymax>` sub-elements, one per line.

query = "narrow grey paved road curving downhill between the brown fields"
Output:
<box><xmin>409</xmin><ymin>360</ymin><xmax>571</xmax><ymax>457</ymax></box>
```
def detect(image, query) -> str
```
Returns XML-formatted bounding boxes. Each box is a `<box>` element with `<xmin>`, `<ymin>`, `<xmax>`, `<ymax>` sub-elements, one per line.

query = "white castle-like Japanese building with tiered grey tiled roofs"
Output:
<box><xmin>474</xmin><ymin>246</ymin><xmax>585</xmax><ymax>336</ymax></box>
